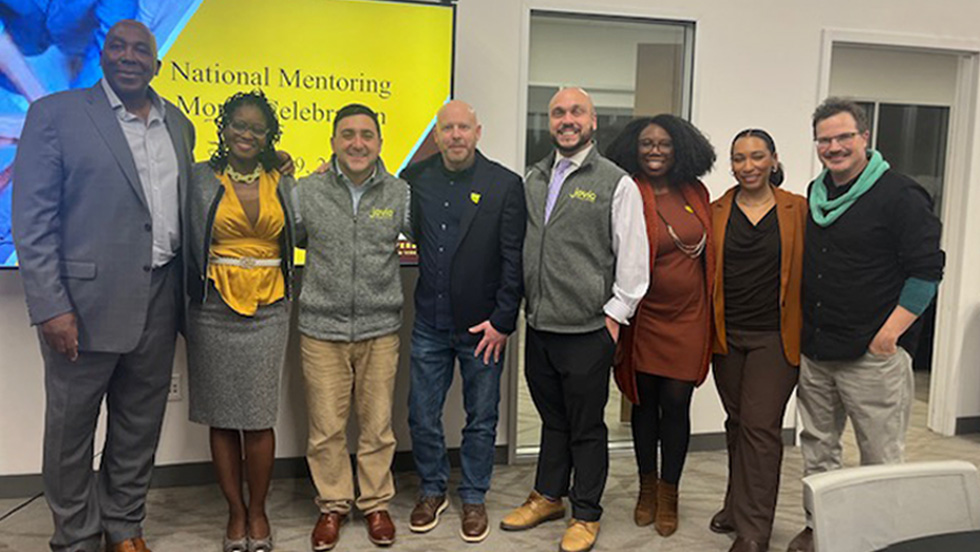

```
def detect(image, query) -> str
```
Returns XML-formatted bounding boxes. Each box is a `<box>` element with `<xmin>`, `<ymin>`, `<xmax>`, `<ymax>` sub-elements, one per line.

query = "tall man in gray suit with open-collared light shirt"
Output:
<box><xmin>13</xmin><ymin>20</ymin><xmax>194</xmax><ymax>552</ymax></box>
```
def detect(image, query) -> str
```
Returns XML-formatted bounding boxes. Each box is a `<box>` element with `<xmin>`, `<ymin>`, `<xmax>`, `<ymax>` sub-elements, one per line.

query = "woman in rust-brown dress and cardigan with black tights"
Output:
<box><xmin>607</xmin><ymin>115</ymin><xmax>715</xmax><ymax>536</ymax></box>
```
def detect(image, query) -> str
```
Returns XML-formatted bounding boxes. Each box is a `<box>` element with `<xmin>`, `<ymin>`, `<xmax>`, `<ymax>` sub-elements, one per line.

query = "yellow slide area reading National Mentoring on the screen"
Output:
<box><xmin>153</xmin><ymin>0</ymin><xmax>453</xmax><ymax>264</ymax></box>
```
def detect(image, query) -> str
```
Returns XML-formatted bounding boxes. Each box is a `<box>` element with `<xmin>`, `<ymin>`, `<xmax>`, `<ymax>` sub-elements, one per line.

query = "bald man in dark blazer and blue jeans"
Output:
<box><xmin>402</xmin><ymin>100</ymin><xmax>526</xmax><ymax>542</ymax></box>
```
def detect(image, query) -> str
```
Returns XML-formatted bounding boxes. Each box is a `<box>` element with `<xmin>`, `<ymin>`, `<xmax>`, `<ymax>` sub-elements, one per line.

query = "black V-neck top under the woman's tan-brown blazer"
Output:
<box><xmin>724</xmin><ymin>202</ymin><xmax>782</xmax><ymax>331</ymax></box>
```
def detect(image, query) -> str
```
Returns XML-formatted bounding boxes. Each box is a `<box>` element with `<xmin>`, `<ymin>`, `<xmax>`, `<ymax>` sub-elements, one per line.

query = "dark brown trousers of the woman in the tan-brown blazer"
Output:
<box><xmin>713</xmin><ymin>328</ymin><xmax>799</xmax><ymax>543</ymax></box>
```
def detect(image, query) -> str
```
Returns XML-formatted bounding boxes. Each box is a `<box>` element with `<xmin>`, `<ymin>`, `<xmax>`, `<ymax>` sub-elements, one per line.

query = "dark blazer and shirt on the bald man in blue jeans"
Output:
<box><xmin>400</xmin><ymin>150</ymin><xmax>527</xmax><ymax>333</ymax></box>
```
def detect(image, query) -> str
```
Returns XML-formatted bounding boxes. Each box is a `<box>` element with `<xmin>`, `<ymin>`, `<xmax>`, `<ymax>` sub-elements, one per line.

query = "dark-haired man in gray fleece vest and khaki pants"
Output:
<box><xmin>296</xmin><ymin>104</ymin><xmax>410</xmax><ymax>550</ymax></box>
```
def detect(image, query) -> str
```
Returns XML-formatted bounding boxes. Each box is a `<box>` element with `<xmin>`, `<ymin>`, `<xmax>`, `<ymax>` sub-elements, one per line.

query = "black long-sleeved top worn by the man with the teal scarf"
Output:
<box><xmin>803</xmin><ymin>166</ymin><xmax>945</xmax><ymax>360</ymax></box>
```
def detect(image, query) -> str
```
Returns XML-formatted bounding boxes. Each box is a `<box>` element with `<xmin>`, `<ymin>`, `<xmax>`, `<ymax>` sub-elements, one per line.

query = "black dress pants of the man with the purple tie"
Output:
<box><xmin>524</xmin><ymin>327</ymin><xmax>616</xmax><ymax>521</ymax></box>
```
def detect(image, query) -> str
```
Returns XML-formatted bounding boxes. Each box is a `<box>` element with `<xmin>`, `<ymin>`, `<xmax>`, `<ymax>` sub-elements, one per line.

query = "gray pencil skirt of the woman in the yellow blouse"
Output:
<box><xmin>187</xmin><ymin>287</ymin><xmax>289</xmax><ymax>430</ymax></box>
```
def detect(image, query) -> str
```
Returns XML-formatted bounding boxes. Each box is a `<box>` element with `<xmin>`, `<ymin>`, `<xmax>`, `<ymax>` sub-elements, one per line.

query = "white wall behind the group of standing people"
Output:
<box><xmin>0</xmin><ymin>0</ymin><xmax>980</xmax><ymax>475</ymax></box>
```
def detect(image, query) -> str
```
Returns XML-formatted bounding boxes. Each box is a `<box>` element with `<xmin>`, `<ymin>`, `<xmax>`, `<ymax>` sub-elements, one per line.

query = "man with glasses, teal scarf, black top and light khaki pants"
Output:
<box><xmin>788</xmin><ymin>98</ymin><xmax>945</xmax><ymax>552</ymax></box>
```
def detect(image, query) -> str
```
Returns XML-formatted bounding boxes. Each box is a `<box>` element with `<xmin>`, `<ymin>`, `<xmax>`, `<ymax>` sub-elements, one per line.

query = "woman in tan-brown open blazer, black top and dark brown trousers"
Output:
<box><xmin>710</xmin><ymin>129</ymin><xmax>807</xmax><ymax>552</ymax></box>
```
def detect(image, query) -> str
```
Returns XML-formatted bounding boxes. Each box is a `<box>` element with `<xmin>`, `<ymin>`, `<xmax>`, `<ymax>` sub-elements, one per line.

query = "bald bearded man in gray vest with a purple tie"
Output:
<box><xmin>500</xmin><ymin>88</ymin><xmax>650</xmax><ymax>552</ymax></box>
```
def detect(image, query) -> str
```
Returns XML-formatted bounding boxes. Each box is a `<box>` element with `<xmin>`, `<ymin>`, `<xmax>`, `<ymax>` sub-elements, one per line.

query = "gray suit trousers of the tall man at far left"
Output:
<box><xmin>41</xmin><ymin>262</ymin><xmax>180</xmax><ymax>552</ymax></box>
